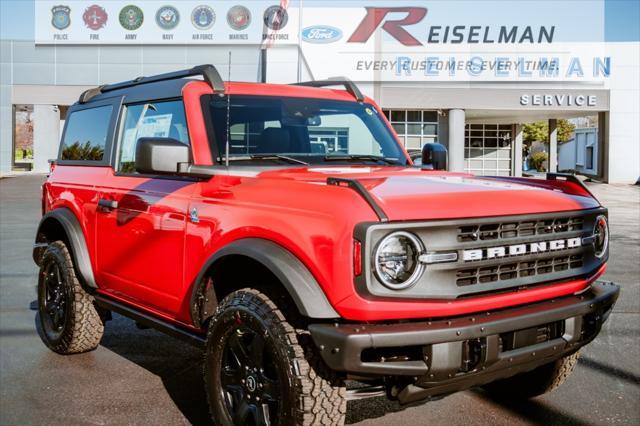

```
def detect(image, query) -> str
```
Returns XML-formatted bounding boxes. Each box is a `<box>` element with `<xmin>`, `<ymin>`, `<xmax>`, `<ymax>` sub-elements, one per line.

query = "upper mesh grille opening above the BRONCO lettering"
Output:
<box><xmin>458</xmin><ymin>216</ymin><xmax>584</xmax><ymax>243</ymax></box>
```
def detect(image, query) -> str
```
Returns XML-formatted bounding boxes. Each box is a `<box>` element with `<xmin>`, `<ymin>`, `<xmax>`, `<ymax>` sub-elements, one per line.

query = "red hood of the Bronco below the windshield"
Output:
<box><xmin>259</xmin><ymin>166</ymin><xmax>599</xmax><ymax>221</ymax></box>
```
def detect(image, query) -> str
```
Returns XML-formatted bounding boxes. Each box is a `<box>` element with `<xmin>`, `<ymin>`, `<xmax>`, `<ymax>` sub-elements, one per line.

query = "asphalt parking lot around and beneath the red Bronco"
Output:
<box><xmin>0</xmin><ymin>175</ymin><xmax>640</xmax><ymax>426</ymax></box>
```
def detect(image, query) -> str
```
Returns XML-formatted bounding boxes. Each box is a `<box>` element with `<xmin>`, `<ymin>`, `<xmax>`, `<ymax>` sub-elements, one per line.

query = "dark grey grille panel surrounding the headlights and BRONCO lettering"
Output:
<box><xmin>354</xmin><ymin>208</ymin><xmax>607</xmax><ymax>300</ymax></box>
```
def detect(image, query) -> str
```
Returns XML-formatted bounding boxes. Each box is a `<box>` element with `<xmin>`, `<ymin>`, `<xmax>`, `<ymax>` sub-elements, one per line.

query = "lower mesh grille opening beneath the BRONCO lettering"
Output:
<box><xmin>456</xmin><ymin>254</ymin><xmax>584</xmax><ymax>286</ymax></box>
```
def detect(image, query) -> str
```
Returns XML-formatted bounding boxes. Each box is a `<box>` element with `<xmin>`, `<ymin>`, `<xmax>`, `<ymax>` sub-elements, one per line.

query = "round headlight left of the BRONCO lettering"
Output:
<box><xmin>374</xmin><ymin>231</ymin><xmax>424</xmax><ymax>290</ymax></box>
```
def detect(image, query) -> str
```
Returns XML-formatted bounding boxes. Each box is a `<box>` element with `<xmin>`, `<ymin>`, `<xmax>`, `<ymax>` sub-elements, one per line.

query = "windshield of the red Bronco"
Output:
<box><xmin>209</xmin><ymin>95</ymin><xmax>407</xmax><ymax>165</ymax></box>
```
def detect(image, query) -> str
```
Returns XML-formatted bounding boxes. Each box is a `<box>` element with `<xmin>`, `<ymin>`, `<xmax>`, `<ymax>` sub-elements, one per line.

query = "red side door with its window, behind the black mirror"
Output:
<box><xmin>96</xmin><ymin>100</ymin><xmax>193</xmax><ymax>316</ymax></box>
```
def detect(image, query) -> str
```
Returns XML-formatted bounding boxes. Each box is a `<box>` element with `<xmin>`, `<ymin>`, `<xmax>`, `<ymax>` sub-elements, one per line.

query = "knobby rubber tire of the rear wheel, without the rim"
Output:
<box><xmin>38</xmin><ymin>241</ymin><xmax>104</xmax><ymax>355</ymax></box>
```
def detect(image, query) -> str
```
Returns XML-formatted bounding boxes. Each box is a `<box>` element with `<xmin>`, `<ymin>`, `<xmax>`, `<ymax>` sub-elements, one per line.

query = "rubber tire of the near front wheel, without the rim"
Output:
<box><xmin>204</xmin><ymin>288</ymin><xmax>347</xmax><ymax>425</ymax></box>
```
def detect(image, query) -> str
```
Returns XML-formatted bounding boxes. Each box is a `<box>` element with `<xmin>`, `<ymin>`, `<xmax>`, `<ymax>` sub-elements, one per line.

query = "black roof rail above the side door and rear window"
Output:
<box><xmin>79</xmin><ymin>64</ymin><xmax>224</xmax><ymax>104</ymax></box>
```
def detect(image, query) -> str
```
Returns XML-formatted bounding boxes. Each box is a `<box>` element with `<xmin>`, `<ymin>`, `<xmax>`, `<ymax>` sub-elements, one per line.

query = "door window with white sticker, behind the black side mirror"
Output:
<box><xmin>117</xmin><ymin>101</ymin><xmax>189</xmax><ymax>173</ymax></box>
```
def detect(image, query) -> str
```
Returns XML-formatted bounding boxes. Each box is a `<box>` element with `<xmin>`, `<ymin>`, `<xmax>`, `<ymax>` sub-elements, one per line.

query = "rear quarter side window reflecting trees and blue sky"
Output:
<box><xmin>60</xmin><ymin>105</ymin><xmax>112</xmax><ymax>161</ymax></box>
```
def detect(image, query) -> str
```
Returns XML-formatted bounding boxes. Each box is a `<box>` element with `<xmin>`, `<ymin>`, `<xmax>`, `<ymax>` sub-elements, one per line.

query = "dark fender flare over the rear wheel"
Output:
<box><xmin>33</xmin><ymin>207</ymin><xmax>98</xmax><ymax>290</ymax></box>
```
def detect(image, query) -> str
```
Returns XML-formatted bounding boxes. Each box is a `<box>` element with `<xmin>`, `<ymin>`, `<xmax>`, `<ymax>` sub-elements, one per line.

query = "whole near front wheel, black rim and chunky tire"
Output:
<box><xmin>204</xmin><ymin>288</ymin><xmax>347</xmax><ymax>426</ymax></box>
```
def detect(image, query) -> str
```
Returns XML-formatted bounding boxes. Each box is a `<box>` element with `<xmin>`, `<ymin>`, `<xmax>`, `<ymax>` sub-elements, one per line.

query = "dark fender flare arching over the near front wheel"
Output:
<box><xmin>191</xmin><ymin>238</ymin><xmax>340</xmax><ymax>326</ymax></box>
